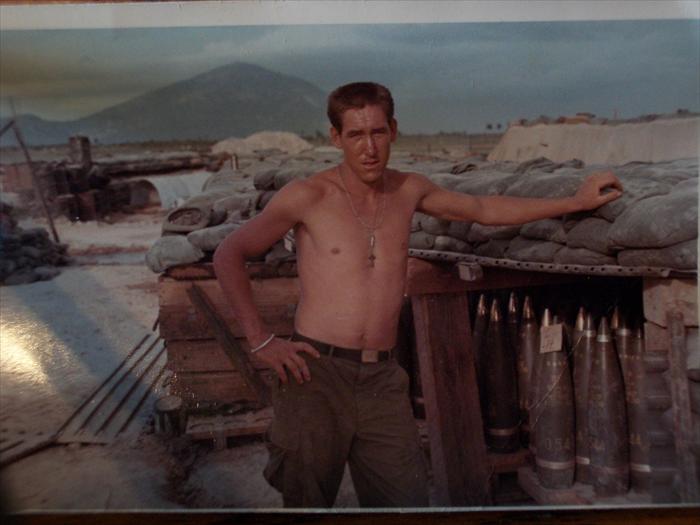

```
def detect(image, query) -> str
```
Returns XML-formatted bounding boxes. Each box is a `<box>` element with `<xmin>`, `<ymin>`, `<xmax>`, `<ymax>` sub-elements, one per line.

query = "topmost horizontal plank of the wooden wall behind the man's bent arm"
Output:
<box><xmin>158</xmin><ymin>277</ymin><xmax>299</xmax><ymax>315</ymax></box>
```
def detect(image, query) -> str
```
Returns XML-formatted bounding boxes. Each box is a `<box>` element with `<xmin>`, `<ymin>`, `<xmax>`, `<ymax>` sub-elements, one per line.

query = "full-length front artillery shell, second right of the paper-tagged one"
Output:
<box><xmin>588</xmin><ymin>316</ymin><xmax>629</xmax><ymax>496</ymax></box>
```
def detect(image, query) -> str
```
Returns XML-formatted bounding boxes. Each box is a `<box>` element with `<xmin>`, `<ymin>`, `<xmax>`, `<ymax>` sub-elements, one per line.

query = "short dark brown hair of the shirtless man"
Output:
<box><xmin>326</xmin><ymin>82</ymin><xmax>394</xmax><ymax>131</ymax></box>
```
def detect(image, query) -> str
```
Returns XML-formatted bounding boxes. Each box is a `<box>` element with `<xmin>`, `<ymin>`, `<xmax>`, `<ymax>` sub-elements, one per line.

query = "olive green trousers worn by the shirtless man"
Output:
<box><xmin>264</xmin><ymin>353</ymin><xmax>428</xmax><ymax>508</ymax></box>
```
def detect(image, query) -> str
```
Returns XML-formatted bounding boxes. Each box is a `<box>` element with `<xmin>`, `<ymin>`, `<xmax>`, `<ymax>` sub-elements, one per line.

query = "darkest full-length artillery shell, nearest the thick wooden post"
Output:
<box><xmin>484</xmin><ymin>298</ymin><xmax>519</xmax><ymax>452</ymax></box>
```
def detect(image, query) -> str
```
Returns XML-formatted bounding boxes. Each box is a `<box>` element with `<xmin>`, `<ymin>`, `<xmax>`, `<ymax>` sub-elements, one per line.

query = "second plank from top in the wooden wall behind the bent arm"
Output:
<box><xmin>158</xmin><ymin>303</ymin><xmax>296</xmax><ymax>342</ymax></box>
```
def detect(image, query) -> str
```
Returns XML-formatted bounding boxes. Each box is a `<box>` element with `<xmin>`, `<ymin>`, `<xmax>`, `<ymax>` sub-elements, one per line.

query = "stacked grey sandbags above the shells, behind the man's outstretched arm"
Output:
<box><xmin>410</xmin><ymin>159</ymin><xmax>698</xmax><ymax>270</ymax></box>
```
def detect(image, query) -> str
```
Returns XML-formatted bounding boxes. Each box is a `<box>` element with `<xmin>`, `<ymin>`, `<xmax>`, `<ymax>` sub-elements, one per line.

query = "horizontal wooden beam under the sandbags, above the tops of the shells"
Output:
<box><xmin>405</xmin><ymin>257</ymin><xmax>580</xmax><ymax>295</ymax></box>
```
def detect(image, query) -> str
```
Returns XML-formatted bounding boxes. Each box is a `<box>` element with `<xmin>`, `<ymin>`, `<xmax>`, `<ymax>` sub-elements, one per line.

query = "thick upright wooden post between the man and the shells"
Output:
<box><xmin>411</xmin><ymin>292</ymin><xmax>491</xmax><ymax>505</ymax></box>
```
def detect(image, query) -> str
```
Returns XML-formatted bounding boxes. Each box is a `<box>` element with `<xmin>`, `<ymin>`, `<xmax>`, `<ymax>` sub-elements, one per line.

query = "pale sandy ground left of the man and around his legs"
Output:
<box><xmin>0</xmin><ymin>210</ymin><xmax>357</xmax><ymax>511</ymax></box>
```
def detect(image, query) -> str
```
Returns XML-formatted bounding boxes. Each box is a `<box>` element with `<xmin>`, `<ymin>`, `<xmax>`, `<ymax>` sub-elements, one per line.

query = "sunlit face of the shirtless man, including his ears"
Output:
<box><xmin>331</xmin><ymin>105</ymin><xmax>396</xmax><ymax>184</ymax></box>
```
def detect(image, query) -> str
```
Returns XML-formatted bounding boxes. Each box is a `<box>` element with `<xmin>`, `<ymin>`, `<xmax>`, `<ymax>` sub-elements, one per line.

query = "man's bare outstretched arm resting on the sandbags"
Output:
<box><xmin>418</xmin><ymin>171</ymin><xmax>622</xmax><ymax>225</ymax></box>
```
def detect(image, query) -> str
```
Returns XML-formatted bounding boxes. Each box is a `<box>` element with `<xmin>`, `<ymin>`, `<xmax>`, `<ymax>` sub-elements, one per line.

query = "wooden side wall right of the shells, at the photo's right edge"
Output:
<box><xmin>643</xmin><ymin>278</ymin><xmax>700</xmax><ymax>503</ymax></box>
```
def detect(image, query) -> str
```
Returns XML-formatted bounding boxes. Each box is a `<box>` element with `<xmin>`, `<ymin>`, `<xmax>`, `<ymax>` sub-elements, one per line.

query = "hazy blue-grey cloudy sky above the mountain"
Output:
<box><xmin>0</xmin><ymin>19</ymin><xmax>700</xmax><ymax>133</ymax></box>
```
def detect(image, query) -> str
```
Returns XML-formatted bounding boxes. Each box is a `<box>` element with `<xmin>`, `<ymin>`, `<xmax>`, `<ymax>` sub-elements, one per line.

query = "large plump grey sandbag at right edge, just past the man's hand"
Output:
<box><xmin>609</xmin><ymin>191</ymin><xmax>698</xmax><ymax>248</ymax></box>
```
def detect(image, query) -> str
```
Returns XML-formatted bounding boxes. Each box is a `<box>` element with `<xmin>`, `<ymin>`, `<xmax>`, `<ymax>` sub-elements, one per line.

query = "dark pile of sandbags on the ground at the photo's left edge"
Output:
<box><xmin>0</xmin><ymin>201</ymin><xmax>69</xmax><ymax>285</ymax></box>
